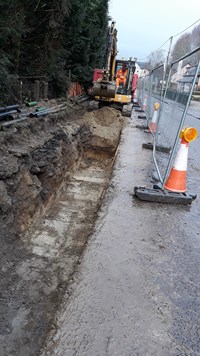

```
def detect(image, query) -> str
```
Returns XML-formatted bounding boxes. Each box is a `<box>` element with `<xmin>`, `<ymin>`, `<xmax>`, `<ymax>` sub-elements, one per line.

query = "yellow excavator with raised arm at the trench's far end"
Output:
<box><xmin>90</xmin><ymin>21</ymin><xmax>137</xmax><ymax>116</ymax></box>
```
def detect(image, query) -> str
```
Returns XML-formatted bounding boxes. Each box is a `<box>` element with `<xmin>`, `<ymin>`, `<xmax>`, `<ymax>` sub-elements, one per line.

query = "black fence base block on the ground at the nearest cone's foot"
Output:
<box><xmin>134</xmin><ymin>187</ymin><xmax>195</xmax><ymax>205</ymax></box>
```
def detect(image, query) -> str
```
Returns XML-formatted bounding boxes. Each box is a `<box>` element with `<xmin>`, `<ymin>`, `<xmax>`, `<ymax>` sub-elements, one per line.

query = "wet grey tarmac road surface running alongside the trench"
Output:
<box><xmin>41</xmin><ymin>103</ymin><xmax>200</xmax><ymax>356</ymax></box>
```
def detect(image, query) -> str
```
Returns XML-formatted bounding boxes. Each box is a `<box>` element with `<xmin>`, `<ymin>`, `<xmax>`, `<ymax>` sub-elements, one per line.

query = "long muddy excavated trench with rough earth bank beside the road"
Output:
<box><xmin>0</xmin><ymin>106</ymin><xmax>123</xmax><ymax>356</ymax></box>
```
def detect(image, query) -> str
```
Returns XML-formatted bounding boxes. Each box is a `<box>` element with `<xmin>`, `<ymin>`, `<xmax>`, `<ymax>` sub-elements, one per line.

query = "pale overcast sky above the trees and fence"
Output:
<box><xmin>109</xmin><ymin>0</ymin><xmax>200</xmax><ymax>61</ymax></box>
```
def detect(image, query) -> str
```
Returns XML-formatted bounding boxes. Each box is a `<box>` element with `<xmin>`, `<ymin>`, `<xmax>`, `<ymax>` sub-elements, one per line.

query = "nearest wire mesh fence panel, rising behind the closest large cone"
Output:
<box><xmin>134</xmin><ymin>47</ymin><xmax>200</xmax><ymax>204</ymax></box>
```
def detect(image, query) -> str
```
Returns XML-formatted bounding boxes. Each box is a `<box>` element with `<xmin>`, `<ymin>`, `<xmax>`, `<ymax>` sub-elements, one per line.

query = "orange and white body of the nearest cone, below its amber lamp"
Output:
<box><xmin>165</xmin><ymin>139</ymin><xmax>188</xmax><ymax>193</ymax></box>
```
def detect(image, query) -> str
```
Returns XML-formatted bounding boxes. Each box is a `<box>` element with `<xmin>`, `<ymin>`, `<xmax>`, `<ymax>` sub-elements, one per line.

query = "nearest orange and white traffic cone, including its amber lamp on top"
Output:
<box><xmin>165</xmin><ymin>128</ymin><xmax>198</xmax><ymax>193</ymax></box>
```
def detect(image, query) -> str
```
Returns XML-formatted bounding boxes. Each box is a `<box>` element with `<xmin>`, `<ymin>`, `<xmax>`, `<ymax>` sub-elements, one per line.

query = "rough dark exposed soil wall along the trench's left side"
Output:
<box><xmin>0</xmin><ymin>106</ymin><xmax>85</xmax><ymax>232</ymax></box>
